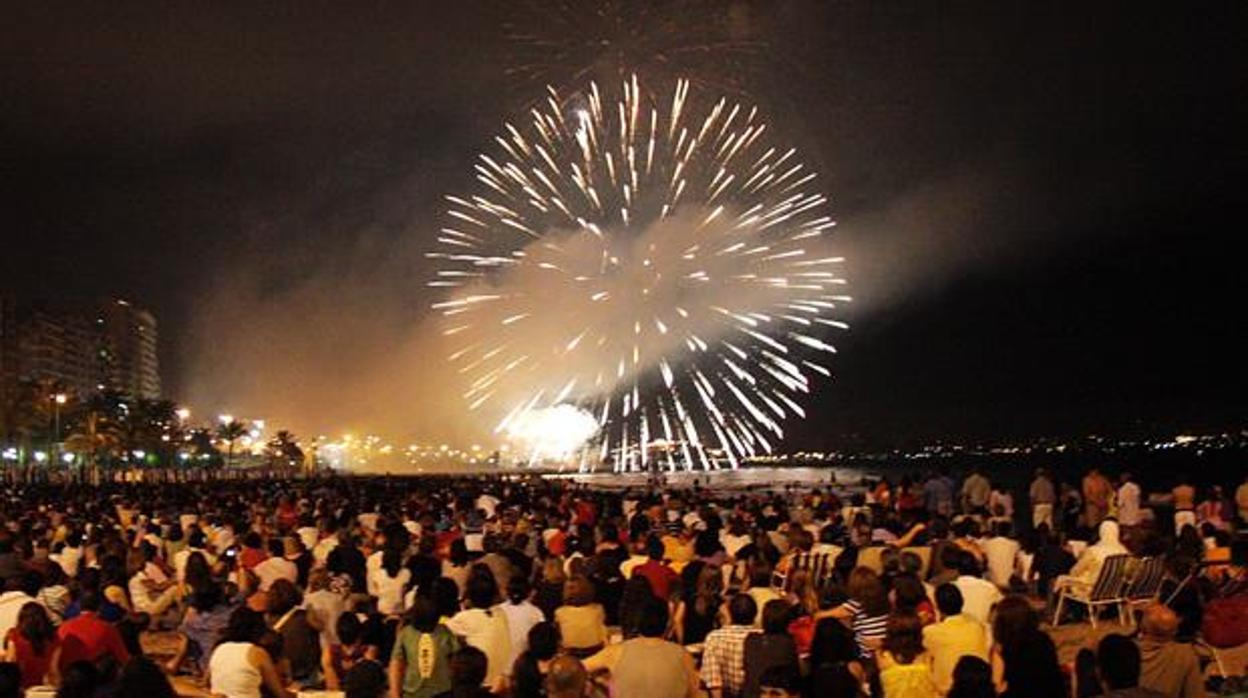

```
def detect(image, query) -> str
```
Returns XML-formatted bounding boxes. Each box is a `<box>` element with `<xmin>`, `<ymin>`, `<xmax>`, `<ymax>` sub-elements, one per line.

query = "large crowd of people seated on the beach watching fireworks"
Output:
<box><xmin>0</xmin><ymin>469</ymin><xmax>1248</xmax><ymax>698</ymax></box>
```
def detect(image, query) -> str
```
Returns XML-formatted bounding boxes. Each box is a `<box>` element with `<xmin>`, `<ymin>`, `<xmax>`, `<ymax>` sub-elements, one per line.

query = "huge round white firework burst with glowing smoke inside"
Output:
<box><xmin>429</xmin><ymin>77</ymin><xmax>849</xmax><ymax>469</ymax></box>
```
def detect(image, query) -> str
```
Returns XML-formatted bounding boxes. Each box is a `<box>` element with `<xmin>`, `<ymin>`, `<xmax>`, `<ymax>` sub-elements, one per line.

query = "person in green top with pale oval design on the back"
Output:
<box><xmin>389</xmin><ymin>596</ymin><xmax>459</xmax><ymax>698</ymax></box>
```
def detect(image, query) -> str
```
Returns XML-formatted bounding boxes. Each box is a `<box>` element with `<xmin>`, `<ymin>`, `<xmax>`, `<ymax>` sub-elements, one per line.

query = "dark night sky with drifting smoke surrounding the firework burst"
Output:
<box><xmin>0</xmin><ymin>0</ymin><xmax>1248</xmax><ymax>445</ymax></box>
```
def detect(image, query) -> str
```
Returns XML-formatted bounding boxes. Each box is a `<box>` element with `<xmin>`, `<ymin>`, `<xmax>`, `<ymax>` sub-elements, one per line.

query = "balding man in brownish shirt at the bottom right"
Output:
<box><xmin>1139</xmin><ymin>603</ymin><xmax>1206</xmax><ymax>698</ymax></box>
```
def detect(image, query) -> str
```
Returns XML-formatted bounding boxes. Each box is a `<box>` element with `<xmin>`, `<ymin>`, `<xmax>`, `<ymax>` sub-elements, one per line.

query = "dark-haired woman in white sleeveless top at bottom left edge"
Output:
<box><xmin>208</xmin><ymin>606</ymin><xmax>295</xmax><ymax>698</ymax></box>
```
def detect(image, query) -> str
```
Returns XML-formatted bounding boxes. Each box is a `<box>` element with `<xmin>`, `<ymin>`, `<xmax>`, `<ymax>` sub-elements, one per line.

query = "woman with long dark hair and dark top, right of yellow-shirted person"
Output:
<box><xmin>990</xmin><ymin>596</ymin><xmax>1066</xmax><ymax>698</ymax></box>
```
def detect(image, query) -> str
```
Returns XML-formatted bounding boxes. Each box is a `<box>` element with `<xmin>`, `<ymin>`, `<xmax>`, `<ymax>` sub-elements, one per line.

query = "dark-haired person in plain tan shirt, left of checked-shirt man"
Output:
<box><xmin>585</xmin><ymin>598</ymin><xmax>698</xmax><ymax>698</ymax></box>
